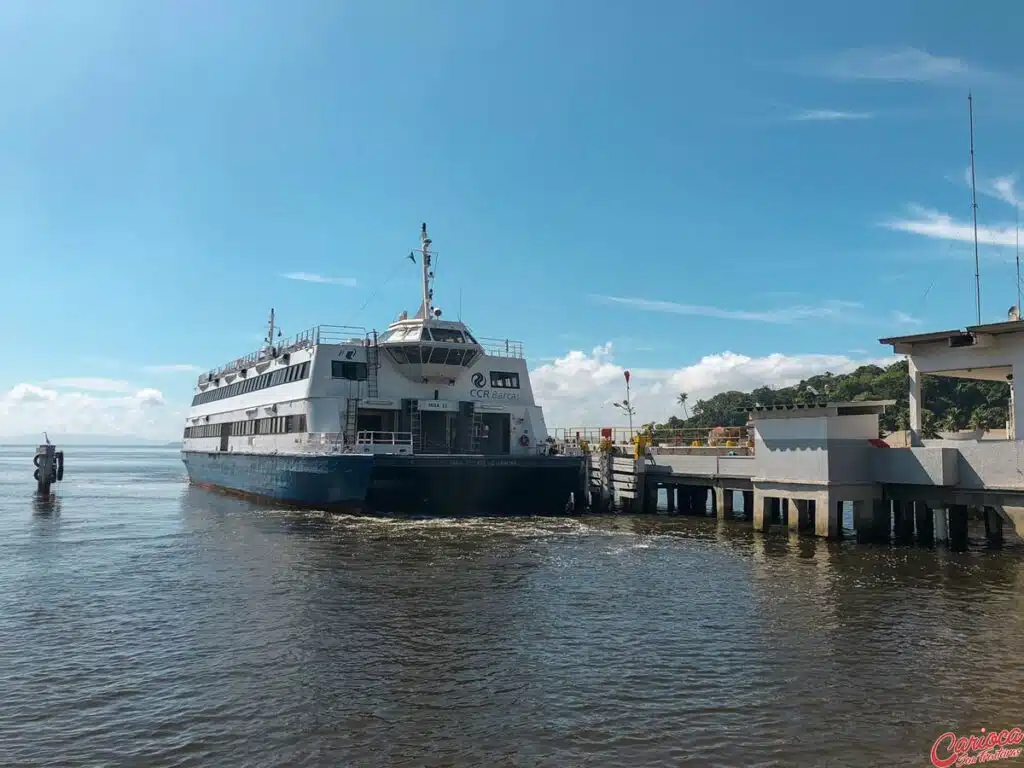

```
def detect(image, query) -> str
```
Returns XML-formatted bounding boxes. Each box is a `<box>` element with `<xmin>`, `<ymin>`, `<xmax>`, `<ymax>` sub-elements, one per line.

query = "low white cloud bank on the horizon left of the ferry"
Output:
<box><xmin>0</xmin><ymin>378</ymin><xmax>184</xmax><ymax>440</ymax></box>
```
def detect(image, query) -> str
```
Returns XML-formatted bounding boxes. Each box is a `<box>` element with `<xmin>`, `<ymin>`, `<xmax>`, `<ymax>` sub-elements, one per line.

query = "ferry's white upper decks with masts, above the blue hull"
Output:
<box><xmin>183</xmin><ymin>225</ymin><xmax>548</xmax><ymax>456</ymax></box>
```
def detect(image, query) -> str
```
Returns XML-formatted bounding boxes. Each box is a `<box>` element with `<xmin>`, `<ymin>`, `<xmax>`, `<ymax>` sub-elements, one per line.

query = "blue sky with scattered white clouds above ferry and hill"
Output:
<box><xmin>0</xmin><ymin>0</ymin><xmax>1024</xmax><ymax>437</ymax></box>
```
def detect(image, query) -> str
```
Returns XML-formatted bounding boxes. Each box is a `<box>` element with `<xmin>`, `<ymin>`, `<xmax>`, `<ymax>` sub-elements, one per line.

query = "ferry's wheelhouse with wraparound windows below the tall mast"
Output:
<box><xmin>377</xmin><ymin>317</ymin><xmax>484</xmax><ymax>381</ymax></box>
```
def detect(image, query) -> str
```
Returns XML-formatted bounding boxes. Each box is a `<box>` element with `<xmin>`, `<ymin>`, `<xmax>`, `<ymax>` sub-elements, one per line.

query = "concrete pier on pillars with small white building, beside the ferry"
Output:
<box><xmin>577</xmin><ymin>400</ymin><xmax>1024</xmax><ymax>548</ymax></box>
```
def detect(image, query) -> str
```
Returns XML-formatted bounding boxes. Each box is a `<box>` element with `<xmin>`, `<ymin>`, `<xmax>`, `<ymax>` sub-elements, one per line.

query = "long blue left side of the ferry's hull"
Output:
<box><xmin>181</xmin><ymin>451</ymin><xmax>374</xmax><ymax>508</ymax></box>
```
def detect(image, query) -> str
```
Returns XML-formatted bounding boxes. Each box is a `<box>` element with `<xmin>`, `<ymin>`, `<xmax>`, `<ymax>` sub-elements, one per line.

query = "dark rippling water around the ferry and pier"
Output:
<box><xmin>0</xmin><ymin>447</ymin><xmax>1024</xmax><ymax>766</ymax></box>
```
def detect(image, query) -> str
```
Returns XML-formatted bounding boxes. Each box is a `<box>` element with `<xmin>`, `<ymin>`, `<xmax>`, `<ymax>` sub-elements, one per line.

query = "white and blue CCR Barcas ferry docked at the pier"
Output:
<box><xmin>182</xmin><ymin>224</ymin><xmax>587</xmax><ymax>515</ymax></box>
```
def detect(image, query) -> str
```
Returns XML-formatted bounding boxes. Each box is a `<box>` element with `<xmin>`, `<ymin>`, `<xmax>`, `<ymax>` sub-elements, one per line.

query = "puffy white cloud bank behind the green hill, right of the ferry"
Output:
<box><xmin>530</xmin><ymin>343</ymin><xmax>898</xmax><ymax>429</ymax></box>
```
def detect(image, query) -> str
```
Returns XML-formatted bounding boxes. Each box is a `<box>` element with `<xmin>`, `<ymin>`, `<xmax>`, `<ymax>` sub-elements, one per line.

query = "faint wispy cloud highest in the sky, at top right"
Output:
<box><xmin>814</xmin><ymin>47</ymin><xmax>966</xmax><ymax>83</ymax></box>
